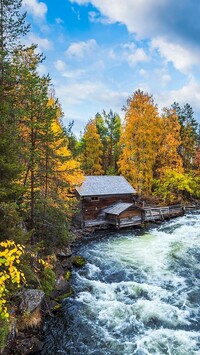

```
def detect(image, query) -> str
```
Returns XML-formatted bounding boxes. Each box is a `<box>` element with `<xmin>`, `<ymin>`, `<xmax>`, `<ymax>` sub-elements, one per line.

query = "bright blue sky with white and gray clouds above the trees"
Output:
<box><xmin>23</xmin><ymin>0</ymin><xmax>200</xmax><ymax>134</ymax></box>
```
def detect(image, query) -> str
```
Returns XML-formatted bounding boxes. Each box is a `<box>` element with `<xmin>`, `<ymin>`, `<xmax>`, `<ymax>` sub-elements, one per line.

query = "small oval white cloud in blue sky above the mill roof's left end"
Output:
<box><xmin>65</xmin><ymin>39</ymin><xmax>97</xmax><ymax>58</ymax></box>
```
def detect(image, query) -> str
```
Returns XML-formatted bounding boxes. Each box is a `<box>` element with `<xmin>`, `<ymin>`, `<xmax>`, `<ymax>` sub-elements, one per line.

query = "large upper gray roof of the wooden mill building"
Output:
<box><xmin>77</xmin><ymin>175</ymin><xmax>136</xmax><ymax>196</ymax></box>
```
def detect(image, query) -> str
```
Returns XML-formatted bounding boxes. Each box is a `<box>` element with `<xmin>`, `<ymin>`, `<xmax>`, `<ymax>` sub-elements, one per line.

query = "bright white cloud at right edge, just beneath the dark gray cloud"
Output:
<box><xmin>152</xmin><ymin>38</ymin><xmax>200</xmax><ymax>73</ymax></box>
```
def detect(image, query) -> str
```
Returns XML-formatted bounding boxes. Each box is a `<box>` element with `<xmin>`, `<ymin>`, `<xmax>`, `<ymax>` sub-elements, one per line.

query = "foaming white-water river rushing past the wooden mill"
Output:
<box><xmin>42</xmin><ymin>212</ymin><xmax>200</xmax><ymax>355</ymax></box>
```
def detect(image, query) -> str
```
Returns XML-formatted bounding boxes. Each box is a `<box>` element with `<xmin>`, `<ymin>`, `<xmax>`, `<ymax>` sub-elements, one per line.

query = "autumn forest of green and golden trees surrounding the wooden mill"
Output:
<box><xmin>0</xmin><ymin>0</ymin><xmax>200</xmax><ymax>349</ymax></box>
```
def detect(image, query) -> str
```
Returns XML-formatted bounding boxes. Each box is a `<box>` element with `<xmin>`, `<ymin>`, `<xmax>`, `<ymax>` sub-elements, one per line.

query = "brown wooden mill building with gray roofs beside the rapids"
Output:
<box><xmin>76</xmin><ymin>176</ymin><xmax>142</xmax><ymax>228</ymax></box>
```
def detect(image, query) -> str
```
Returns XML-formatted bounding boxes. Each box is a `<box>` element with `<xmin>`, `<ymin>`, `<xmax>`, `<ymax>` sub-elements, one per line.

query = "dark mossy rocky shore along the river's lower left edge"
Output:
<box><xmin>2</xmin><ymin>241</ymin><xmax>85</xmax><ymax>355</ymax></box>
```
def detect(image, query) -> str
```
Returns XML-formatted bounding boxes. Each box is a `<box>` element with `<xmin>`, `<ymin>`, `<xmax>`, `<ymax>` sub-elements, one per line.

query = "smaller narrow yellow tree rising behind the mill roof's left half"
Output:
<box><xmin>81</xmin><ymin>120</ymin><xmax>103</xmax><ymax>175</ymax></box>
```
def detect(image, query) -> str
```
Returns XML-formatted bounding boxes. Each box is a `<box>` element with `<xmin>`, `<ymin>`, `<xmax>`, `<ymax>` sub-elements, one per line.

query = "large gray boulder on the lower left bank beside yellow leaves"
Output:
<box><xmin>20</xmin><ymin>289</ymin><xmax>45</xmax><ymax>313</ymax></box>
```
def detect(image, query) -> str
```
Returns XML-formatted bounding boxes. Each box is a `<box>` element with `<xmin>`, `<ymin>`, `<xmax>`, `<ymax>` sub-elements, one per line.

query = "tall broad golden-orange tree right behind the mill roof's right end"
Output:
<box><xmin>118</xmin><ymin>90</ymin><xmax>161</xmax><ymax>193</ymax></box>
